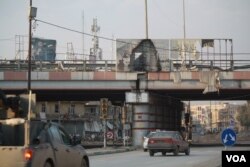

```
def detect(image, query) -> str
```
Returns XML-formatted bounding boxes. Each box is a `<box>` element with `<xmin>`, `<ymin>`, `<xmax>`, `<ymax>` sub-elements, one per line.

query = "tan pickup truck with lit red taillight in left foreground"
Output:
<box><xmin>0</xmin><ymin>119</ymin><xmax>89</xmax><ymax>167</ymax></box>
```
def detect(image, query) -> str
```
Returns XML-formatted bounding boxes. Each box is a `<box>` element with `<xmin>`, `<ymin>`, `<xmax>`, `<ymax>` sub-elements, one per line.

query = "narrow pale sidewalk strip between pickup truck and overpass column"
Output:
<box><xmin>86</xmin><ymin>147</ymin><xmax>136</xmax><ymax>156</ymax></box>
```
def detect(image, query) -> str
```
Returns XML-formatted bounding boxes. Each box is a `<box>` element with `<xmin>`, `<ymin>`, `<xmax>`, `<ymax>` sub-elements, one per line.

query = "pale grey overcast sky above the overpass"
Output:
<box><xmin>0</xmin><ymin>0</ymin><xmax>250</xmax><ymax>59</ymax></box>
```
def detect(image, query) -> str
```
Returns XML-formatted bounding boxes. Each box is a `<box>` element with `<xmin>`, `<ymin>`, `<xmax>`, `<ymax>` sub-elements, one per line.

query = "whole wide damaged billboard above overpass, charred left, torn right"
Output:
<box><xmin>116</xmin><ymin>39</ymin><xmax>233</xmax><ymax>71</ymax></box>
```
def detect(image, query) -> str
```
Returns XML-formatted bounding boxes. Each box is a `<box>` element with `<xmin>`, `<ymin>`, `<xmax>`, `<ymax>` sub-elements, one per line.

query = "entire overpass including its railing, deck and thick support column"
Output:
<box><xmin>0</xmin><ymin>61</ymin><xmax>250</xmax><ymax>145</ymax></box>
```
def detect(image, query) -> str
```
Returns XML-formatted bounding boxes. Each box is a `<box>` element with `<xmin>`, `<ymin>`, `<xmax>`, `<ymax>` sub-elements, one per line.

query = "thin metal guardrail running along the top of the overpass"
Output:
<box><xmin>0</xmin><ymin>59</ymin><xmax>250</xmax><ymax>72</ymax></box>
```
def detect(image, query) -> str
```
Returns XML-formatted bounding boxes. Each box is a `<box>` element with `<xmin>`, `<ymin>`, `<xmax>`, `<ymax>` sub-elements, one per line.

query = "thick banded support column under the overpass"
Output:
<box><xmin>131</xmin><ymin>94</ymin><xmax>184</xmax><ymax>146</ymax></box>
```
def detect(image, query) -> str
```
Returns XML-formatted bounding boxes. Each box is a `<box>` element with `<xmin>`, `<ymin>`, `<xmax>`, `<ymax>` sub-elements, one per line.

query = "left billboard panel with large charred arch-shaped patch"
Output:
<box><xmin>116</xmin><ymin>39</ymin><xmax>169</xmax><ymax>71</ymax></box>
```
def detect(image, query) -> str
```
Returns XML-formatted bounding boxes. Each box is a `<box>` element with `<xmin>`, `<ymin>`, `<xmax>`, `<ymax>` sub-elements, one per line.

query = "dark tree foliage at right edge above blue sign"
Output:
<box><xmin>237</xmin><ymin>101</ymin><xmax>250</xmax><ymax>130</ymax></box>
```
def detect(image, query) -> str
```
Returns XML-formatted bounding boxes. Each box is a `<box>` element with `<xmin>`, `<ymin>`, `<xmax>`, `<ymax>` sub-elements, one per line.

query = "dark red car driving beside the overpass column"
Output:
<box><xmin>148</xmin><ymin>131</ymin><xmax>190</xmax><ymax>156</ymax></box>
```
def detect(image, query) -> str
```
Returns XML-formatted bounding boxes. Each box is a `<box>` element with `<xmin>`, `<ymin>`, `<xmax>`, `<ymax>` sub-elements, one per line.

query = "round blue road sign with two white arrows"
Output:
<box><xmin>221</xmin><ymin>128</ymin><xmax>236</xmax><ymax>146</ymax></box>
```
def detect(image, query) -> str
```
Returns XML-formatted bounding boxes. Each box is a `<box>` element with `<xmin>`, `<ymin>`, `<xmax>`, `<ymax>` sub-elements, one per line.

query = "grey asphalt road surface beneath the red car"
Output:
<box><xmin>90</xmin><ymin>147</ymin><xmax>250</xmax><ymax>167</ymax></box>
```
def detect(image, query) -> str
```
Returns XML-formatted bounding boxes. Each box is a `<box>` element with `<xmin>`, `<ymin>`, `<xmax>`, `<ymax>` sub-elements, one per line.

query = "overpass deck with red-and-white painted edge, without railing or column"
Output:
<box><xmin>0</xmin><ymin>64</ymin><xmax>250</xmax><ymax>101</ymax></box>
